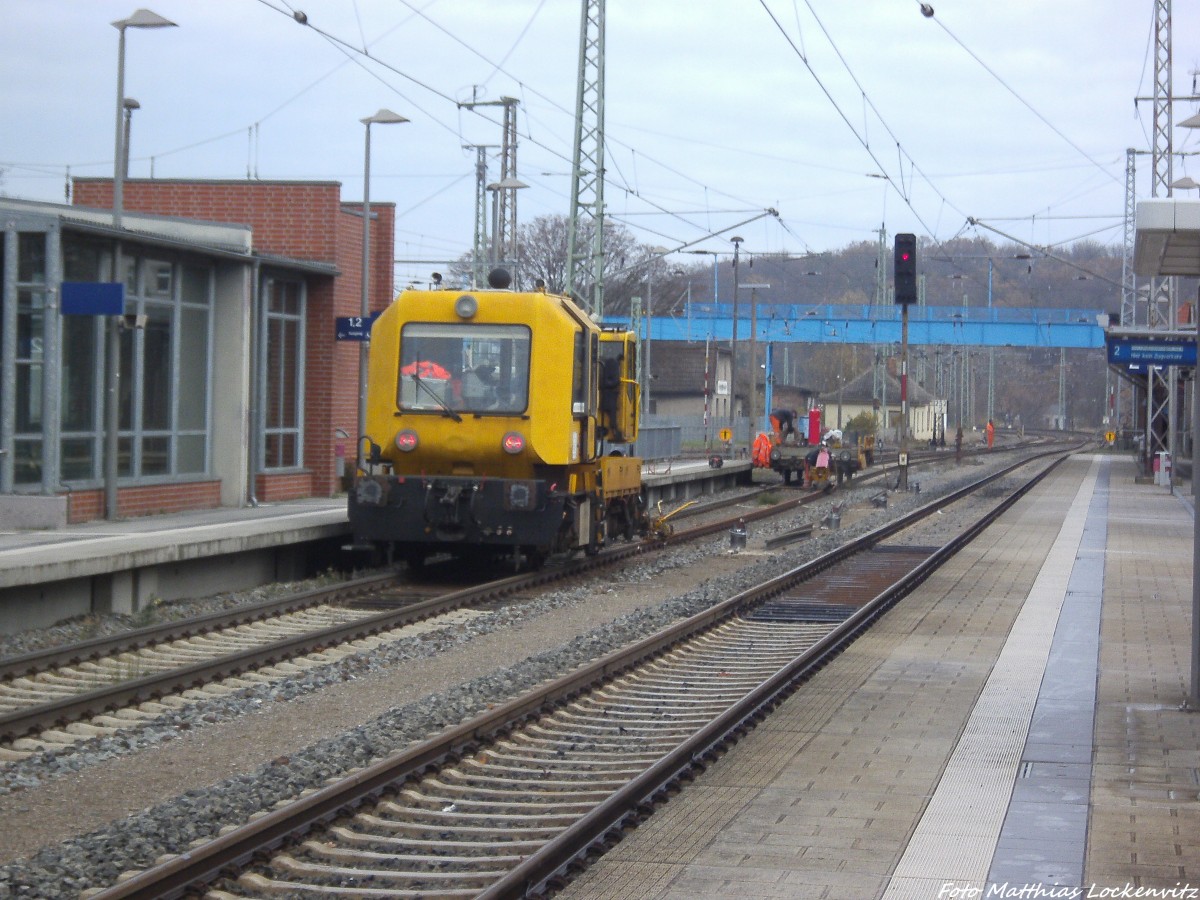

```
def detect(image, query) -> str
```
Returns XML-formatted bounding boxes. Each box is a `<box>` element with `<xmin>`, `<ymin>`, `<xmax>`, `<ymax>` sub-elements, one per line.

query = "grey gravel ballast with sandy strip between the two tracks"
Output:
<box><xmin>0</xmin><ymin>454</ymin><xmax>1056</xmax><ymax>898</ymax></box>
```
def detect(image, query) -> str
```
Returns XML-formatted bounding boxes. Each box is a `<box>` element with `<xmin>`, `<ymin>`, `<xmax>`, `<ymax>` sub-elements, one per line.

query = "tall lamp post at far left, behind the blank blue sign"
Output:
<box><xmin>104</xmin><ymin>10</ymin><xmax>175</xmax><ymax>520</ymax></box>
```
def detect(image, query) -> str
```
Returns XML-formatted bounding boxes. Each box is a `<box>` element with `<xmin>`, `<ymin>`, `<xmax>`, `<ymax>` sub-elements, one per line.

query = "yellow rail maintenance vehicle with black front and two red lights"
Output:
<box><xmin>348</xmin><ymin>269</ymin><xmax>649</xmax><ymax>568</ymax></box>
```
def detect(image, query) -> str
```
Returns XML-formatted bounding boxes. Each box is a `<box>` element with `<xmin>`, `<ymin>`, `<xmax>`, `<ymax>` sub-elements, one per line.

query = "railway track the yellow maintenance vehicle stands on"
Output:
<box><xmin>0</xmin><ymin>441</ymin><xmax>1070</xmax><ymax>764</ymax></box>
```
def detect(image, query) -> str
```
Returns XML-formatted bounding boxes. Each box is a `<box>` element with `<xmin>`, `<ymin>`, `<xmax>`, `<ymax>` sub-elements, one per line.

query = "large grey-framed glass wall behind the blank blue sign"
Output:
<box><xmin>0</xmin><ymin>229</ymin><xmax>216</xmax><ymax>492</ymax></box>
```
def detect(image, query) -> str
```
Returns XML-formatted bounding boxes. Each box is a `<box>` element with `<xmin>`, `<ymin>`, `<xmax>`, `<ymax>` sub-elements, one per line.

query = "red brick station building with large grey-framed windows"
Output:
<box><xmin>0</xmin><ymin>179</ymin><xmax>395</xmax><ymax>527</ymax></box>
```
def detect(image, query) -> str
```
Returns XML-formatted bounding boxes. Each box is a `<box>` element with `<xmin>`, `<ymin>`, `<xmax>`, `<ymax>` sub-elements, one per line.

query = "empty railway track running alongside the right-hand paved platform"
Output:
<box><xmin>96</xmin><ymin>448</ymin><xmax>1070</xmax><ymax>900</ymax></box>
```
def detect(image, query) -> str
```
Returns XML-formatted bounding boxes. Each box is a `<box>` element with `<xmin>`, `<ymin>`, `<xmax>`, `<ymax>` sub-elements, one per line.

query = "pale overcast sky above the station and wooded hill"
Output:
<box><xmin>0</xmin><ymin>0</ymin><xmax>1200</xmax><ymax>281</ymax></box>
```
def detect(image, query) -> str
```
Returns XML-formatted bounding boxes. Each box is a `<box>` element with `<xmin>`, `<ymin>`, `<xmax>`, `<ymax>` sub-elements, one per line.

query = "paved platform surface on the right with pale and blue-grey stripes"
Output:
<box><xmin>558</xmin><ymin>455</ymin><xmax>1200</xmax><ymax>900</ymax></box>
